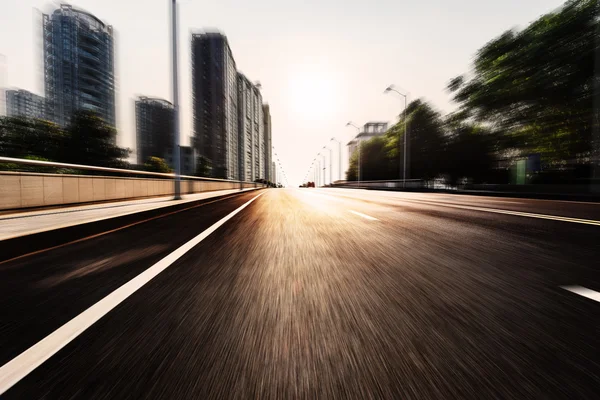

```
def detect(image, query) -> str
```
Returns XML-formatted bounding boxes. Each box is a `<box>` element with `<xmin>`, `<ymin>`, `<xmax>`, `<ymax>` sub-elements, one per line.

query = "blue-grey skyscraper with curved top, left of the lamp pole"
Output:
<box><xmin>43</xmin><ymin>4</ymin><xmax>115</xmax><ymax>126</ymax></box>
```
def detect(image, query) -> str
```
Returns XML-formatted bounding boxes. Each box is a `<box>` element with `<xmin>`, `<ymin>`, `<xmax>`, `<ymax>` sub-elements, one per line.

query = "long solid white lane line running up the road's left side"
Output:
<box><xmin>0</xmin><ymin>192</ymin><xmax>265</xmax><ymax>395</ymax></box>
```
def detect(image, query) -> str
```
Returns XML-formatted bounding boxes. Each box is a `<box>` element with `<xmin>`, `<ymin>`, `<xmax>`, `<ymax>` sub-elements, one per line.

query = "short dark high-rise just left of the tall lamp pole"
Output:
<box><xmin>135</xmin><ymin>96</ymin><xmax>174</xmax><ymax>164</ymax></box>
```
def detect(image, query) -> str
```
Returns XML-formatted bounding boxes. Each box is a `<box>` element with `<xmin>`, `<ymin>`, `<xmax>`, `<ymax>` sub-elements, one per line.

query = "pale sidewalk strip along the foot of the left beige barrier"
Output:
<box><xmin>0</xmin><ymin>188</ymin><xmax>254</xmax><ymax>240</ymax></box>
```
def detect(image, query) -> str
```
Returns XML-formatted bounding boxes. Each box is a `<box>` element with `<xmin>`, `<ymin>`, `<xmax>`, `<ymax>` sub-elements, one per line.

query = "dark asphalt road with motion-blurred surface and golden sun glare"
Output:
<box><xmin>0</xmin><ymin>189</ymin><xmax>600</xmax><ymax>399</ymax></box>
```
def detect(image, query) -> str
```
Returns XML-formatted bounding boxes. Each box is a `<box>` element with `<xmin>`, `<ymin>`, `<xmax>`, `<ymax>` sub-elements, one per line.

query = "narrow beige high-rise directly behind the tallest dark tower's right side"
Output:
<box><xmin>238</xmin><ymin>73</ymin><xmax>265</xmax><ymax>181</ymax></box>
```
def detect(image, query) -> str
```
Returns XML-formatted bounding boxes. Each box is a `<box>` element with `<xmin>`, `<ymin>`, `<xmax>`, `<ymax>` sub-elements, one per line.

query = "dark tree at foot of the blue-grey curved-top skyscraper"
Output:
<box><xmin>64</xmin><ymin>111</ymin><xmax>131</xmax><ymax>168</ymax></box>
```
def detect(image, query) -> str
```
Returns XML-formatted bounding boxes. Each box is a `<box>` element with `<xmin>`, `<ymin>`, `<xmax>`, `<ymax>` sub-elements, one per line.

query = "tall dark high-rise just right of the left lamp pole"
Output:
<box><xmin>192</xmin><ymin>32</ymin><xmax>239</xmax><ymax>179</ymax></box>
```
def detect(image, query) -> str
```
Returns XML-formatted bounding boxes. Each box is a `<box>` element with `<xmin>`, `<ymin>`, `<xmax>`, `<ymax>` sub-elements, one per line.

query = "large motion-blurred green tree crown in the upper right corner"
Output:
<box><xmin>449</xmin><ymin>0</ymin><xmax>600</xmax><ymax>162</ymax></box>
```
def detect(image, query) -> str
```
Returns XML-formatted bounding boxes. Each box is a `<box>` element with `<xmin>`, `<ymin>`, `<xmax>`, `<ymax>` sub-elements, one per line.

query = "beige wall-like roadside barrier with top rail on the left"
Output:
<box><xmin>0</xmin><ymin>157</ymin><xmax>265</xmax><ymax>210</ymax></box>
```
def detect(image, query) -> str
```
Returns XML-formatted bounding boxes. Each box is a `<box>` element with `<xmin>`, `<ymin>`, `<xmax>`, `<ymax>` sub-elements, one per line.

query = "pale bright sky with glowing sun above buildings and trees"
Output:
<box><xmin>0</xmin><ymin>0</ymin><xmax>563</xmax><ymax>186</ymax></box>
